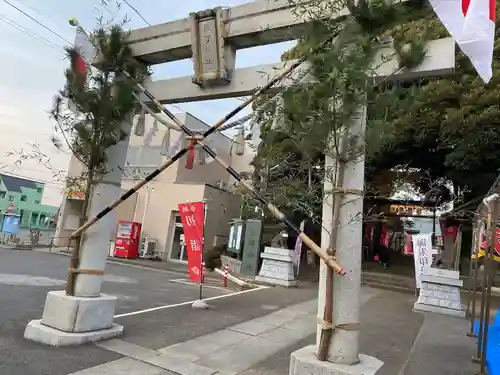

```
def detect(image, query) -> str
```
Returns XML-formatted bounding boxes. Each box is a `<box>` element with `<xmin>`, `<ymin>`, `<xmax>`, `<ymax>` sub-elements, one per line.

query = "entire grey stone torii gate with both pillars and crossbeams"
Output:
<box><xmin>25</xmin><ymin>0</ymin><xmax>455</xmax><ymax>374</ymax></box>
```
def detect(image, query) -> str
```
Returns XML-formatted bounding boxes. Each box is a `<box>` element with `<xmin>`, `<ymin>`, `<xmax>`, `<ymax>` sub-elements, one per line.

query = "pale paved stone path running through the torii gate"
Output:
<box><xmin>67</xmin><ymin>289</ymin><xmax>382</xmax><ymax>375</ymax></box>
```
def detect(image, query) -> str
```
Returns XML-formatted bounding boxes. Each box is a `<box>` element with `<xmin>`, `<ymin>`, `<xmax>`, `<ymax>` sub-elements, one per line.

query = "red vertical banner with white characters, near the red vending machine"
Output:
<box><xmin>178</xmin><ymin>202</ymin><xmax>205</xmax><ymax>283</ymax></box>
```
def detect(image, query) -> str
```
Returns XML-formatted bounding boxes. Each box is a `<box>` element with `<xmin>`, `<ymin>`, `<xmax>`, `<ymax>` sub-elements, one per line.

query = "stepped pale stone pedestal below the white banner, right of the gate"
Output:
<box><xmin>413</xmin><ymin>268</ymin><xmax>465</xmax><ymax>317</ymax></box>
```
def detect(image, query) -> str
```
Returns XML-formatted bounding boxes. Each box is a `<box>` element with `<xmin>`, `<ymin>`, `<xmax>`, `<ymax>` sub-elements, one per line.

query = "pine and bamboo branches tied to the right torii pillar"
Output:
<box><xmin>254</xmin><ymin>1</ymin><xmax>435</xmax><ymax>226</ymax></box>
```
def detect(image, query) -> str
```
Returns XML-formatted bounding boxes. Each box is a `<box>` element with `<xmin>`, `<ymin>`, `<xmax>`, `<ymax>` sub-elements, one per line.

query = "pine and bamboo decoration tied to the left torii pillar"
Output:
<box><xmin>51</xmin><ymin>25</ymin><xmax>149</xmax><ymax>295</ymax></box>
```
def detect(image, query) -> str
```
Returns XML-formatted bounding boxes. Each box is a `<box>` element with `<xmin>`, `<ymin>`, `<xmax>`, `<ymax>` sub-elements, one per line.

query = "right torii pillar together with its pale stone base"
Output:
<box><xmin>290</xmin><ymin>105</ymin><xmax>382</xmax><ymax>375</ymax></box>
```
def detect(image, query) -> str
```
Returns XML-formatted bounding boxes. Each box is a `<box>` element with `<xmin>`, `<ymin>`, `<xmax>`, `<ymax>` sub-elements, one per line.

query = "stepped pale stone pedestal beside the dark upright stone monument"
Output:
<box><xmin>255</xmin><ymin>247</ymin><xmax>297</xmax><ymax>287</ymax></box>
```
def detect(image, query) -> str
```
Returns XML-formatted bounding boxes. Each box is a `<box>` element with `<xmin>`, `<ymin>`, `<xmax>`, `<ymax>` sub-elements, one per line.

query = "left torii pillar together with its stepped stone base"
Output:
<box><xmin>24</xmin><ymin>121</ymin><xmax>132</xmax><ymax>346</ymax></box>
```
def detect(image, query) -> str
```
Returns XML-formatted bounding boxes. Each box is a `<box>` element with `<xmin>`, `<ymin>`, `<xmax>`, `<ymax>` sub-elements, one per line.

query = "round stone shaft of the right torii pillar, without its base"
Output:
<box><xmin>316</xmin><ymin>105</ymin><xmax>366</xmax><ymax>365</ymax></box>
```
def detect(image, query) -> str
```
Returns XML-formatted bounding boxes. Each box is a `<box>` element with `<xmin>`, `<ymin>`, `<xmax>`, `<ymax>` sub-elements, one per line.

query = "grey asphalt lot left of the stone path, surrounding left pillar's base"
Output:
<box><xmin>0</xmin><ymin>250</ymin><xmax>316</xmax><ymax>375</ymax></box>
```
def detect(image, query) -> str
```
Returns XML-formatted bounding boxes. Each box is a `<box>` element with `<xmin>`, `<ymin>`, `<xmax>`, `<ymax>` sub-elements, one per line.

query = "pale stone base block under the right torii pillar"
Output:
<box><xmin>289</xmin><ymin>345</ymin><xmax>384</xmax><ymax>375</ymax></box>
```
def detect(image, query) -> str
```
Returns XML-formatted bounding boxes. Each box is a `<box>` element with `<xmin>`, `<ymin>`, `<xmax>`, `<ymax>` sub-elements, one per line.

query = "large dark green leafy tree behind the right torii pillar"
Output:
<box><xmin>254</xmin><ymin>1</ymin><xmax>500</xmax><ymax>217</ymax></box>
